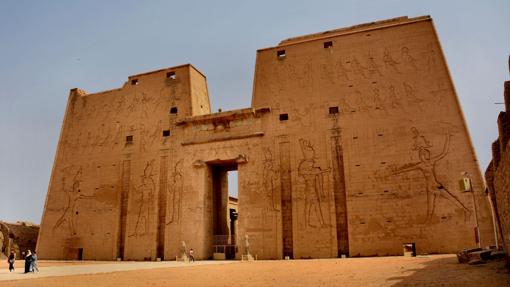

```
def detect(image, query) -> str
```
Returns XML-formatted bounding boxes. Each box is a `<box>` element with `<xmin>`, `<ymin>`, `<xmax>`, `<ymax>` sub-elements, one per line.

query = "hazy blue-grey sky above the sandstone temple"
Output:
<box><xmin>0</xmin><ymin>0</ymin><xmax>510</xmax><ymax>223</ymax></box>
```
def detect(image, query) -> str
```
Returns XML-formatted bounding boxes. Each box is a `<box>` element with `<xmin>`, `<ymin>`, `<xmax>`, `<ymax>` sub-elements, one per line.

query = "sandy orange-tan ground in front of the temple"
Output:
<box><xmin>0</xmin><ymin>255</ymin><xmax>510</xmax><ymax>287</ymax></box>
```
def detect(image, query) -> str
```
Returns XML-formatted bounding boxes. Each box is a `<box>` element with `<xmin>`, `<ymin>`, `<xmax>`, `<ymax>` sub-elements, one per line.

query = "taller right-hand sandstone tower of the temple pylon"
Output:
<box><xmin>253</xmin><ymin>17</ymin><xmax>493</xmax><ymax>257</ymax></box>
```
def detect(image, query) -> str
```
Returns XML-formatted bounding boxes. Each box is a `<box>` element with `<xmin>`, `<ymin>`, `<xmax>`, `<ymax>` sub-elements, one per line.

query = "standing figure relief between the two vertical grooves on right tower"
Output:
<box><xmin>298</xmin><ymin>139</ymin><xmax>330</xmax><ymax>227</ymax></box>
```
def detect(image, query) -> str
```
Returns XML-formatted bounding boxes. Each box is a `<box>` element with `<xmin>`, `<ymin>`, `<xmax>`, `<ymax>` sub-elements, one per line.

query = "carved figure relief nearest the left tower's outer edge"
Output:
<box><xmin>53</xmin><ymin>166</ymin><xmax>95</xmax><ymax>236</ymax></box>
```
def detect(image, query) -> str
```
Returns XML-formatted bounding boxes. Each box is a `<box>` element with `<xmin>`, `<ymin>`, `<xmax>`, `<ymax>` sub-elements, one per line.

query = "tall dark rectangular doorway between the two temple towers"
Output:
<box><xmin>208</xmin><ymin>160</ymin><xmax>238</xmax><ymax>260</ymax></box>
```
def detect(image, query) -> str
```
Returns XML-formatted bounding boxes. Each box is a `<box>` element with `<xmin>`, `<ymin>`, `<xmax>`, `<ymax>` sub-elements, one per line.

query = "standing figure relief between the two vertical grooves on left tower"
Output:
<box><xmin>129</xmin><ymin>160</ymin><xmax>156</xmax><ymax>237</ymax></box>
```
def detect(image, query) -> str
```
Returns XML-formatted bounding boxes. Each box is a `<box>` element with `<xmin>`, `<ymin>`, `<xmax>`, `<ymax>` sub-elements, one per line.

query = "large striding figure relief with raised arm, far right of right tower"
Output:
<box><xmin>389</xmin><ymin>127</ymin><xmax>471</xmax><ymax>220</ymax></box>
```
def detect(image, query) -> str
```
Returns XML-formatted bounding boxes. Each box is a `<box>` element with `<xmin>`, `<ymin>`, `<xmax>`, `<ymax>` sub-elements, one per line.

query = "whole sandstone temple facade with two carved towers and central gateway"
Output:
<box><xmin>38</xmin><ymin>16</ymin><xmax>493</xmax><ymax>260</ymax></box>
